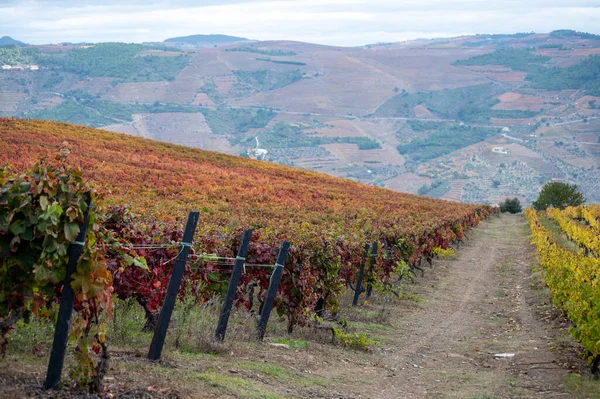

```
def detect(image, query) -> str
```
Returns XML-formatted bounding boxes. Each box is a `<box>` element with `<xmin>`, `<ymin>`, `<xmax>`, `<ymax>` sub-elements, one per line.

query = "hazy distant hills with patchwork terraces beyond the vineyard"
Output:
<box><xmin>0</xmin><ymin>30</ymin><xmax>600</xmax><ymax>203</ymax></box>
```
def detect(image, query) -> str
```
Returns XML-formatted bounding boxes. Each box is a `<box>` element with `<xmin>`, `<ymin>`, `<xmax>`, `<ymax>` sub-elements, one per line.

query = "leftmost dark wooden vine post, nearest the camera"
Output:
<box><xmin>44</xmin><ymin>192</ymin><xmax>92</xmax><ymax>389</ymax></box>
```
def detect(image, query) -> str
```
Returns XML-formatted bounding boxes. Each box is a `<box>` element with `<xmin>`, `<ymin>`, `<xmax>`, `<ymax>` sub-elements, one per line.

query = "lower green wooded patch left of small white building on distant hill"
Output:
<box><xmin>397</xmin><ymin>125</ymin><xmax>498</xmax><ymax>162</ymax></box>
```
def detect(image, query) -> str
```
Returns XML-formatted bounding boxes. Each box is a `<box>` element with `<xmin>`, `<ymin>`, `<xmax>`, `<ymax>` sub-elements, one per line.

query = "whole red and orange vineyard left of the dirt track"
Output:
<box><xmin>0</xmin><ymin>119</ymin><xmax>492</xmax><ymax>389</ymax></box>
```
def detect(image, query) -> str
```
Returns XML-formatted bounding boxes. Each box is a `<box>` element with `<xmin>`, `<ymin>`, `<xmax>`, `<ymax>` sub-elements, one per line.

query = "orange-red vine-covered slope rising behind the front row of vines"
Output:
<box><xmin>0</xmin><ymin>118</ymin><xmax>477</xmax><ymax>238</ymax></box>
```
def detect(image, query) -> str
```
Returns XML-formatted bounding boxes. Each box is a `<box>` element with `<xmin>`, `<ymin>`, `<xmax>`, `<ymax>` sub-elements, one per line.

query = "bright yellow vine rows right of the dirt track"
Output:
<box><xmin>525</xmin><ymin>205</ymin><xmax>600</xmax><ymax>375</ymax></box>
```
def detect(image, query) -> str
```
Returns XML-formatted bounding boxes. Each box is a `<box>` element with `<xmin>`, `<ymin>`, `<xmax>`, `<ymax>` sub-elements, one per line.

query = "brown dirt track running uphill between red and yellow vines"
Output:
<box><xmin>322</xmin><ymin>216</ymin><xmax>581</xmax><ymax>398</ymax></box>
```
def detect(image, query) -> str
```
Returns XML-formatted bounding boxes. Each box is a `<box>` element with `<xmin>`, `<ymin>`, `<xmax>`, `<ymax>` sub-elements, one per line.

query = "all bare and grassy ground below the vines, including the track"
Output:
<box><xmin>0</xmin><ymin>216</ymin><xmax>600</xmax><ymax>399</ymax></box>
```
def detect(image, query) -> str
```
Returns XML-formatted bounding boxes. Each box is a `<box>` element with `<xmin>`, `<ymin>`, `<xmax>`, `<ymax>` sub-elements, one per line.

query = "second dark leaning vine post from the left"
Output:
<box><xmin>148</xmin><ymin>211</ymin><xmax>200</xmax><ymax>360</ymax></box>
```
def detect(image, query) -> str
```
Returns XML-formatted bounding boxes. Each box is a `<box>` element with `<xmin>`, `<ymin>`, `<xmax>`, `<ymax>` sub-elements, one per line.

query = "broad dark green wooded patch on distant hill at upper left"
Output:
<box><xmin>40</xmin><ymin>43</ymin><xmax>189</xmax><ymax>82</ymax></box>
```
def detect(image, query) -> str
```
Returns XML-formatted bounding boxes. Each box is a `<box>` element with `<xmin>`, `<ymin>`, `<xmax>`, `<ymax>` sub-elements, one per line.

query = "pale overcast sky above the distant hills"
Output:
<box><xmin>0</xmin><ymin>0</ymin><xmax>600</xmax><ymax>46</ymax></box>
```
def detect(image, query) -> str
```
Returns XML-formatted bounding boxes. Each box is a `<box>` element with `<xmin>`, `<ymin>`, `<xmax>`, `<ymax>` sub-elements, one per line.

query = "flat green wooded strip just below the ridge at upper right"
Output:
<box><xmin>453</xmin><ymin>47</ymin><xmax>550</xmax><ymax>72</ymax></box>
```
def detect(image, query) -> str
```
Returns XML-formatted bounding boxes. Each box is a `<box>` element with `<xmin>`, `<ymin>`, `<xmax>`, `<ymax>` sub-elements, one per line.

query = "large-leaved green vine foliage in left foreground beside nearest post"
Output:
<box><xmin>0</xmin><ymin>158</ymin><xmax>101</xmax><ymax>320</ymax></box>
